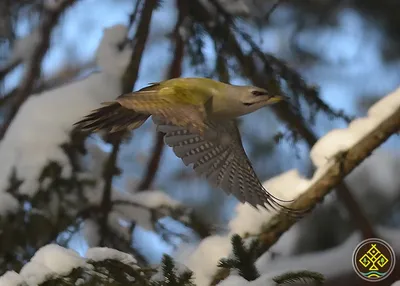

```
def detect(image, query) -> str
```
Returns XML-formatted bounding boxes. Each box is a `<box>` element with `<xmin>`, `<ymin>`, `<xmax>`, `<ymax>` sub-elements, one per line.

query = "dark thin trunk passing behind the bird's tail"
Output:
<box><xmin>99</xmin><ymin>0</ymin><xmax>157</xmax><ymax>245</ymax></box>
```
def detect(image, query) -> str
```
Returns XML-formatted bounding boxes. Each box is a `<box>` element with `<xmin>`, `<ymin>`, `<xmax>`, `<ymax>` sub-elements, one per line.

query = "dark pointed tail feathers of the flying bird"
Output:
<box><xmin>74</xmin><ymin>102</ymin><xmax>150</xmax><ymax>133</ymax></box>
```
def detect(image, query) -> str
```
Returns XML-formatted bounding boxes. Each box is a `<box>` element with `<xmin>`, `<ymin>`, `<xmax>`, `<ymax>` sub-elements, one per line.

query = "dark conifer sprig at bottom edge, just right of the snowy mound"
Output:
<box><xmin>151</xmin><ymin>255</ymin><xmax>194</xmax><ymax>286</ymax></box>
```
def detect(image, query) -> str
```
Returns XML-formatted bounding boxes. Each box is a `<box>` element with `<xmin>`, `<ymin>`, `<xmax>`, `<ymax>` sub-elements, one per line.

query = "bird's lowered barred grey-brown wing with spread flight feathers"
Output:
<box><xmin>153</xmin><ymin>116</ymin><xmax>296</xmax><ymax>213</ymax></box>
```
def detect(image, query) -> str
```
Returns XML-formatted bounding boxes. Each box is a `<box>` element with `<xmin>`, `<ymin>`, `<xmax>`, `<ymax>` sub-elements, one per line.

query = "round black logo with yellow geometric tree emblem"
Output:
<box><xmin>353</xmin><ymin>238</ymin><xmax>396</xmax><ymax>282</ymax></box>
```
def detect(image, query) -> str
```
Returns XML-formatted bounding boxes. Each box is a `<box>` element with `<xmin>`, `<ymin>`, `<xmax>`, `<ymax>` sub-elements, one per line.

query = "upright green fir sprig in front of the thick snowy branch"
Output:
<box><xmin>218</xmin><ymin>234</ymin><xmax>260</xmax><ymax>281</ymax></box>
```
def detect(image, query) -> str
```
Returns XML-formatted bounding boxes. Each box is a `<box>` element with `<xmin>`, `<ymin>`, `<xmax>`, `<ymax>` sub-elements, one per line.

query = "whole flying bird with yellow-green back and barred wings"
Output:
<box><xmin>77</xmin><ymin>78</ymin><xmax>300</xmax><ymax>211</ymax></box>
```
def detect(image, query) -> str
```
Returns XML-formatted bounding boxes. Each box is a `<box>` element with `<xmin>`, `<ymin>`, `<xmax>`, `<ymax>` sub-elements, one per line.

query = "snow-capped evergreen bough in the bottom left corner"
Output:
<box><xmin>0</xmin><ymin>244</ymin><xmax>152</xmax><ymax>286</ymax></box>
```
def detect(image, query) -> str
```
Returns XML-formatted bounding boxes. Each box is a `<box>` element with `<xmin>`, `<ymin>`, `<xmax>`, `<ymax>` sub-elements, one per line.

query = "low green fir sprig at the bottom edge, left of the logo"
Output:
<box><xmin>273</xmin><ymin>270</ymin><xmax>325</xmax><ymax>285</ymax></box>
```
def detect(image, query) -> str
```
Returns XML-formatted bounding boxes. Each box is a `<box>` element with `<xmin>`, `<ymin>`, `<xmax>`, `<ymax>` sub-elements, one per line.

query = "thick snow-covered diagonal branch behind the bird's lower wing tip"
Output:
<box><xmin>182</xmin><ymin>89</ymin><xmax>400</xmax><ymax>285</ymax></box>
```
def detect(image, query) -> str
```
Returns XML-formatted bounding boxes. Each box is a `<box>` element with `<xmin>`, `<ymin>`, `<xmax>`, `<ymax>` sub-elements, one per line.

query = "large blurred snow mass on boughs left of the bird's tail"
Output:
<box><xmin>0</xmin><ymin>25</ymin><xmax>132</xmax><ymax>197</ymax></box>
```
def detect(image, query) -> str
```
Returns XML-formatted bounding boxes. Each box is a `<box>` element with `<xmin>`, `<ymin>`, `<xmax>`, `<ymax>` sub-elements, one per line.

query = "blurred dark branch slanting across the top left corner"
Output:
<box><xmin>0</xmin><ymin>0</ymin><xmax>76</xmax><ymax>140</ymax></box>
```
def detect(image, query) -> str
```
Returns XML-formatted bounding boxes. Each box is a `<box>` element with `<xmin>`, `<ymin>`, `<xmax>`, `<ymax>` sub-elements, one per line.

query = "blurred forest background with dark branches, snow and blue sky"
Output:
<box><xmin>0</xmin><ymin>0</ymin><xmax>400</xmax><ymax>286</ymax></box>
